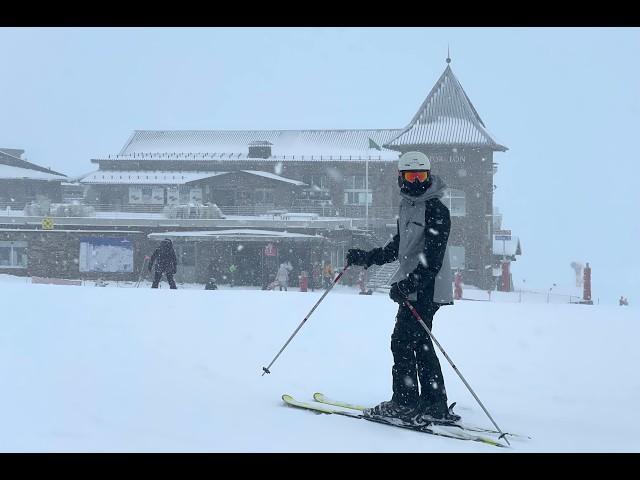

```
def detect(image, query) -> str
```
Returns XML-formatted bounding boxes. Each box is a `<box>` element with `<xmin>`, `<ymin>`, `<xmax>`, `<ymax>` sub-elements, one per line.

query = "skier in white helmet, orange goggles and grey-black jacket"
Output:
<box><xmin>346</xmin><ymin>152</ymin><xmax>460</xmax><ymax>426</ymax></box>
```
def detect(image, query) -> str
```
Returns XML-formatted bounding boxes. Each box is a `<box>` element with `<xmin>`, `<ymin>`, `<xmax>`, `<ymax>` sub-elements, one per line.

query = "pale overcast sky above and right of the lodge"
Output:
<box><xmin>0</xmin><ymin>28</ymin><xmax>640</xmax><ymax>304</ymax></box>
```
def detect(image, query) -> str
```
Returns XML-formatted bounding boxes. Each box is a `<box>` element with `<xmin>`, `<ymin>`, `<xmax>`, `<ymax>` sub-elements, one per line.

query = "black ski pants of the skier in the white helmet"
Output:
<box><xmin>391</xmin><ymin>303</ymin><xmax>447</xmax><ymax>411</ymax></box>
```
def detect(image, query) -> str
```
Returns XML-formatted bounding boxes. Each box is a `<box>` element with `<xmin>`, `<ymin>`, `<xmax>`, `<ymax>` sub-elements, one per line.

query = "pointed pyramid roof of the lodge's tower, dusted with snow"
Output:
<box><xmin>385</xmin><ymin>65</ymin><xmax>507</xmax><ymax>151</ymax></box>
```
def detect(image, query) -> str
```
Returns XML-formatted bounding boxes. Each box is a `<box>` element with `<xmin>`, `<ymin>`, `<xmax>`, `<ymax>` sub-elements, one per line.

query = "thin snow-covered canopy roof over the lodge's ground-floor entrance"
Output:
<box><xmin>148</xmin><ymin>228</ymin><xmax>324</xmax><ymax>242</ymax></box>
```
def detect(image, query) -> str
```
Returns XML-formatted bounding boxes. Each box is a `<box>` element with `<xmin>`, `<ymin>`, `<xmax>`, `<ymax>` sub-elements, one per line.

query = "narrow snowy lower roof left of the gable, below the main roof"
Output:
<box><xmin>80</xmin><ymin>170</ymin><xmax>227</xmax><ymax>185</ymax></box>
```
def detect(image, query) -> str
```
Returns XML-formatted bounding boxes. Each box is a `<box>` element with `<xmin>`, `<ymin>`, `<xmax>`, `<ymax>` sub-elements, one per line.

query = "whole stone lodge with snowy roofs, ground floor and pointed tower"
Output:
<box><xmin>0</xmin><ymin>59</ymin><xmax>519</xmax><ymax>289</ymax></box>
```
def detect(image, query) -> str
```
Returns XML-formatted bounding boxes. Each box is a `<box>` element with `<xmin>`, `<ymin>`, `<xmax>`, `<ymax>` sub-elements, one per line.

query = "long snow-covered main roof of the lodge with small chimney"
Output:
<box><xmin>110</xmin><ymin>129</ymin><xmax>401</xmax><ymax>161</ymax></box>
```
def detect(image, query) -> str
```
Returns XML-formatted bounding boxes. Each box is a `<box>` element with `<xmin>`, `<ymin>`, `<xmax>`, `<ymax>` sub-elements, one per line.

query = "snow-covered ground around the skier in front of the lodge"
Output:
<box><xmin>0</xmin><ymin>276</ymin><xmax>640</xmax><ymax>453</ymax></box>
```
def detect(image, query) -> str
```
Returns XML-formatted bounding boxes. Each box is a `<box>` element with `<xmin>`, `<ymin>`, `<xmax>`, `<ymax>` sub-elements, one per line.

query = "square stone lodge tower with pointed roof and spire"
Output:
<box><xmin>384</xmin><ymin>55</ymin><xmax>507</xmax><ymax>288</ymax></box>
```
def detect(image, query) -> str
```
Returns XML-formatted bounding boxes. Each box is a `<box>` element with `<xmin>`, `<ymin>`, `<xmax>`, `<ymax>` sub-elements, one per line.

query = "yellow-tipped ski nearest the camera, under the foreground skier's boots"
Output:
<box><xmin>282</xmin><ymin>394</ymin><xmax>508</xmax><ymax>448</ymax></box>
